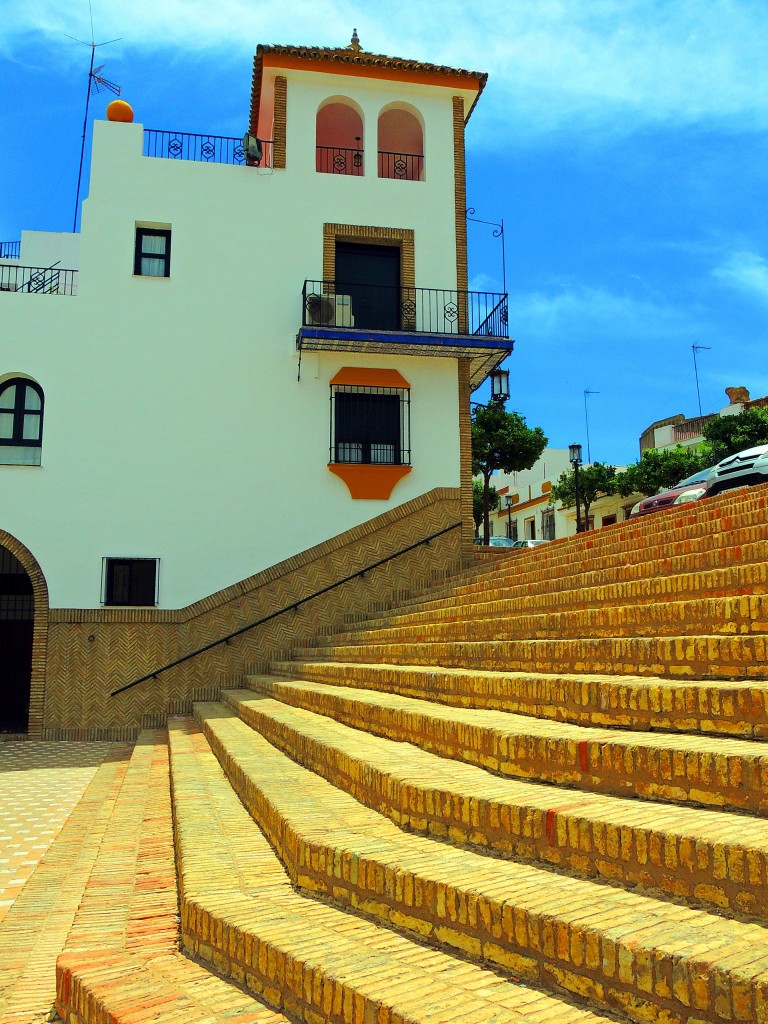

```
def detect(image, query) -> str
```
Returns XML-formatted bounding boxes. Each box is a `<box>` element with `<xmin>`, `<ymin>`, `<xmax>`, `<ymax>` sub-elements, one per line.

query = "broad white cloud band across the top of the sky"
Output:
<box><xmin>0</xmin><ymin>0</ymin><xmax>768</xmax><ymax>142</ymax></box>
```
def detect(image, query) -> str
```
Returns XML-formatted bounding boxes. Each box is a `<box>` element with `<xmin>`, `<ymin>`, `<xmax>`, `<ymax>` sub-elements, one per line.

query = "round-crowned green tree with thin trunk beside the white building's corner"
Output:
<box><xmin>472</xmin><ymin>398</ymin><xmax>548</xmax><ymax>544</ymax></box>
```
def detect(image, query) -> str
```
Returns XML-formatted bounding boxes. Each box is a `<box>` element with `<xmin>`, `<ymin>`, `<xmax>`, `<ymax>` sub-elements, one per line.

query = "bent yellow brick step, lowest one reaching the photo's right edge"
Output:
<box><xmin>196</xmin><ymin>705</ymin><xmax>768</xmax><ymax>1024</ymax></box>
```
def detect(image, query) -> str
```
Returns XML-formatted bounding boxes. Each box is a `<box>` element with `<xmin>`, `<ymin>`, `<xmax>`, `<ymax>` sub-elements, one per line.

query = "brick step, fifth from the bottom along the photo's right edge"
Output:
<box><xmin>303</xmin><ymin>636</ymin><xmax>768</xmax><ymax>679</ymax></box>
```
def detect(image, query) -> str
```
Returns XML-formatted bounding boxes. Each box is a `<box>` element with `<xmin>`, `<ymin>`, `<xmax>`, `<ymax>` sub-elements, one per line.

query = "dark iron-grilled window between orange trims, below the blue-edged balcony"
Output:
<box><xmin>331</xmin><ymin>384</ymin><xmax>411</xmax><ymax>466</ymax></box>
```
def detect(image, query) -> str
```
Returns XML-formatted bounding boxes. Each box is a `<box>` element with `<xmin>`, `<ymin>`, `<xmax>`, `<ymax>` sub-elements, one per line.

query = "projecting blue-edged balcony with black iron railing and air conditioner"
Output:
<box><xmin>296</xmin><ymin>280</ymin><xmax>514</xmax><ymax>387</ymax></box>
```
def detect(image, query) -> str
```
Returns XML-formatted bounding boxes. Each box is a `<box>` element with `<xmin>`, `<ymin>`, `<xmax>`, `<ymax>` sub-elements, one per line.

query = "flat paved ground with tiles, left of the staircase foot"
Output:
<box><xmin>0</xmin><ymin>741</ymin><xmax>130</xmax><ymax>1024</ymax></box>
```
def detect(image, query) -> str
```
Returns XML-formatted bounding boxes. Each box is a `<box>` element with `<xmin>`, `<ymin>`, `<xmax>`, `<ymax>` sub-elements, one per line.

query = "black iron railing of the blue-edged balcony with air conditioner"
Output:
<box><xmin>301</xmin><ymin>280</ymin><xmax>509</xmax><ymax>338</ymax></box>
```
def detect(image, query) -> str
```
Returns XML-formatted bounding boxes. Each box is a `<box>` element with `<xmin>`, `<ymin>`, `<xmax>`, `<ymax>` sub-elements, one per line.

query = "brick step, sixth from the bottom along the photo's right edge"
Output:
<box><xmin>325</xmin><ymin>595</ymin><xmax>768</xmax><ymax>646</ymax></box>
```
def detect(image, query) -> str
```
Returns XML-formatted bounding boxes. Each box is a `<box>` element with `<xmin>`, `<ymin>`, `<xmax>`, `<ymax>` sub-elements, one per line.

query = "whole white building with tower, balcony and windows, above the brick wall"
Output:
<box><xmin>0</xmin><ymin>36</ymin><xmax>512</xmax><ymax>734</ymax></box>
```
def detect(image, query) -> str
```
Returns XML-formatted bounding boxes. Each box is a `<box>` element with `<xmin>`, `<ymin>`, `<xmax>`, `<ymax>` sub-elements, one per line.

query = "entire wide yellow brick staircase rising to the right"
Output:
<box><xmin>57</xmin><ymin>486</ymin><xmax>768</xmax><ymax>1024</ymax></box>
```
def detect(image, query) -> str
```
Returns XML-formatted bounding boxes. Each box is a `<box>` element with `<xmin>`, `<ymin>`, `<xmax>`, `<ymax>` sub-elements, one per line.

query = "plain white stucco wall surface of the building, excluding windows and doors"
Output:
<box><xmin>0</xmin><ymin>61</ymin><xmax>475</xmax><ymax>607</ymax></box>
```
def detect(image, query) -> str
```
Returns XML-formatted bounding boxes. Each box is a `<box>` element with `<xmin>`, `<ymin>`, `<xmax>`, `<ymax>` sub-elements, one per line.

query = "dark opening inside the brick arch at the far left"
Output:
<box><xmin>0</xmin><ymin>545</ymin><xmax>35</xmax><ymax>732</ymax></box>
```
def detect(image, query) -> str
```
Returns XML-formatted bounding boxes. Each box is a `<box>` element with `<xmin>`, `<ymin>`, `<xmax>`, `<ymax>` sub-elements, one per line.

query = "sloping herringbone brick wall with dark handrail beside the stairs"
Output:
<box><xmin>38</xmin><ymin>487</ymin><xmax>463</xmax><ymax>739</ymax></box>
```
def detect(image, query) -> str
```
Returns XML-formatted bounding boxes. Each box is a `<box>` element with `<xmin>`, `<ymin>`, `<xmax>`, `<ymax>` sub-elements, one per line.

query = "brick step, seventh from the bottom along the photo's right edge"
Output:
<box><xmin>348</xmin><ymin>561</ymin><xmax>768</xmax><ymax>635</ymax></box>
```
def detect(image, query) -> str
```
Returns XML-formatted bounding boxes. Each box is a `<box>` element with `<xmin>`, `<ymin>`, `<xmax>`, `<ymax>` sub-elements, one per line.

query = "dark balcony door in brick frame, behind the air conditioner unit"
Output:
<box><xmin>336</xmin><ymin>242</ymin><xmax>400</xmax><ymax>331</ymax></box>
